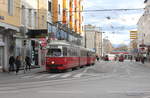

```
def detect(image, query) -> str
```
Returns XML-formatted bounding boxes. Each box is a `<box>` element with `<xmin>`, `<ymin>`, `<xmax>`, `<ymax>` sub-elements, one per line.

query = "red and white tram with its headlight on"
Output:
<box><xmin>46</xmin><ymin>41</ymin><xmax>95</xmax><ymax>71</ymax></box>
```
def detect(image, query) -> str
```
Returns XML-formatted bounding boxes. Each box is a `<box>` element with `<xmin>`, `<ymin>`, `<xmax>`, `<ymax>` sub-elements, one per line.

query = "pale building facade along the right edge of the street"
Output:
<box><xmin>137</xmin><ymin>0</ymin><xmax>150</xmax><ymax>61</ymax></box>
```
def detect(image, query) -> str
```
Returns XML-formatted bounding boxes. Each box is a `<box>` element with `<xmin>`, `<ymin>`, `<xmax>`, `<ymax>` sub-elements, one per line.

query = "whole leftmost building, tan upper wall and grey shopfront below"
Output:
<box><xmin>0</xmin><ymin>0</ymin><xmax>20</xmax><ymax>71</ymax></box>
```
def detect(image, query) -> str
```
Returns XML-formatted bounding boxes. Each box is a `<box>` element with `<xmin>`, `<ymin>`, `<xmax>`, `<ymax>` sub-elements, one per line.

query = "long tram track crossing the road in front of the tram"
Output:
<box><xmin>0</xmin><ymin>69</ymin><xmax>114</xmax><ymax>92</ymax></box>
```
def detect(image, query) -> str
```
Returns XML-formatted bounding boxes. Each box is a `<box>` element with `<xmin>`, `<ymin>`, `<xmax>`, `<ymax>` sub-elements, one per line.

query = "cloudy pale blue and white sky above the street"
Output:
<box><xmin>83</xmin><ymin>0</ymin><xmax>145</xmax><ymax>44</ymax></box>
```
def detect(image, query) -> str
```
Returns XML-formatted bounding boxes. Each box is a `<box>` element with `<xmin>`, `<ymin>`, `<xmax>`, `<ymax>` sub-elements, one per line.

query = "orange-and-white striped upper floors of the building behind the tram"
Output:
<box><xmin>52</xmin><ymin>0</ymin><xmax>83</xmax><ymax>35</ymax></box>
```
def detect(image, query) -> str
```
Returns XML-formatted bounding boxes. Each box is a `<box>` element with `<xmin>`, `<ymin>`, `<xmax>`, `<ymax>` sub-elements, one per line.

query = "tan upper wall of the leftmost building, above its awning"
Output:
<box><xmin>0</xmin><ymin>0</ymin><xmax>20</xmax><ymax>27</ymax></box>
